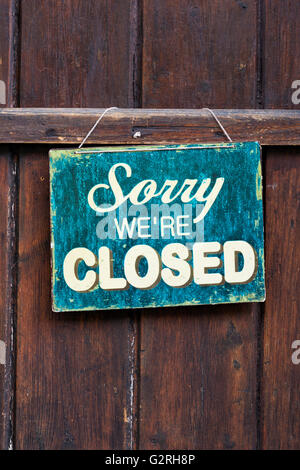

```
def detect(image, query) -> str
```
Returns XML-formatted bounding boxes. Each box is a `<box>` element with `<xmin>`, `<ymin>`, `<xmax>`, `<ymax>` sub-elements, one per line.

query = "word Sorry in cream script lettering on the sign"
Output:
<box><xmin>88</xmin><ymin>163</ymin><xmax>224</xmax><ymax>223</ymax></box>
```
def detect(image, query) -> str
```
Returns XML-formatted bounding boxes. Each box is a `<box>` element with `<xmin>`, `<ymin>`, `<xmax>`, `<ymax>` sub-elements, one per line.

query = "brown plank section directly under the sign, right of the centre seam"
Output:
<box><xmin>140</xmin><ymin>304</ymin><xmax>257</xmax><ymax>450</ymax></box>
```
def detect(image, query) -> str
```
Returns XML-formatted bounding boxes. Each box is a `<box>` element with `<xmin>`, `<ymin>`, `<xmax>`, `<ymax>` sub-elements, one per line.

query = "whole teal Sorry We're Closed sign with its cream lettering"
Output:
<box><xmin>50</xmin><ymin>142</ymin><xmax>265</xmax><ymax>311</ymax></box>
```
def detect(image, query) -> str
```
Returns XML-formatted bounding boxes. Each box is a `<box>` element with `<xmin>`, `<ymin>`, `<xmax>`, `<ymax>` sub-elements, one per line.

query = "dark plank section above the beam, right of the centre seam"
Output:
<box><xmin>143</xmin><ymin>0</ymin><xmax>257</xmax><ymax>108</ymax></box>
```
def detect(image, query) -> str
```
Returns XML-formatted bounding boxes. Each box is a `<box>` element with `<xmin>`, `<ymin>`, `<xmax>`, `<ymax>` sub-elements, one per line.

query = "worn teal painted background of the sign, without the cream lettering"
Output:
<box><xmin>50</xmin><ymin>142</ymin><xmax>265</xmax><ymax>312</ymax></box>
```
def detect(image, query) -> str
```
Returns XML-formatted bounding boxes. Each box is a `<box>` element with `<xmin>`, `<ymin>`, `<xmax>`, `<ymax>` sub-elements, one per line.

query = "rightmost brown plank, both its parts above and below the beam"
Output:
<box><xmin>261</xmin><ymin>0</ymin><xmax>300</xmax><ymax>449</ymax></box>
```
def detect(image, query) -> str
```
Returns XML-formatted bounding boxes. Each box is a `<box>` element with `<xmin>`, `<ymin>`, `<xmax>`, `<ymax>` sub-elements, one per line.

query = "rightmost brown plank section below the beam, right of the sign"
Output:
<box><xmin>262</xmin><ymin>148</ymin><xmax>300</xmax><ymax>449</ymax></box>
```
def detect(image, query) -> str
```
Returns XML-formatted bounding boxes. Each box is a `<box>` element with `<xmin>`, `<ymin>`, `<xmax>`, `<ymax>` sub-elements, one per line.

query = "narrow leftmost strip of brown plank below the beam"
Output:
<box><xmin>0</xmin><ymin>147</ymin><xmax>18</xmax><ymax>449</ymax></box>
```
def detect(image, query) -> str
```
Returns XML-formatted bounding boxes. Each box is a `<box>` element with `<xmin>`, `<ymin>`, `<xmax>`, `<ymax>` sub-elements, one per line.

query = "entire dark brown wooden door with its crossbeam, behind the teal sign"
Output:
<box><xmin>0</xmin><ymin>0</ymin><xmax>300</xmax><ymax>449</ymax></box>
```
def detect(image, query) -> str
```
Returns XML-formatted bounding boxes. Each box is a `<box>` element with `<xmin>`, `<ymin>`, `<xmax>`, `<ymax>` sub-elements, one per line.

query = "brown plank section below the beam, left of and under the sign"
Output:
<box><xmin>16</xmin><ymin>149</ymin><xmax>133</xmax><ymax>449</ymax></box>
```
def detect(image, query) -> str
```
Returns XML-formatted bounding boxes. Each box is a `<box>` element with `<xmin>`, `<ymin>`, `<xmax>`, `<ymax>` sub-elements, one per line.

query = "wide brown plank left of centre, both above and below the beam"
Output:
<box><xmin>16</xmin><ymin>0</ymin><xmax>136</xmax><ymax>449</ymax></box>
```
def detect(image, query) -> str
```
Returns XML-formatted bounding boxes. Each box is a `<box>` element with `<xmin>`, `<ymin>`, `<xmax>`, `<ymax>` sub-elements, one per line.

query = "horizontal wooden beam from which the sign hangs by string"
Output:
<box><xmin>0</xmin><ymin>108</ymin><xmax>300</xmax><ymax>145</ymax></box>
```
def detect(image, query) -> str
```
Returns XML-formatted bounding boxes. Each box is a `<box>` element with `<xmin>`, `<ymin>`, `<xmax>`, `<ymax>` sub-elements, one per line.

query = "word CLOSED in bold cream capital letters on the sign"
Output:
<box><xmin>63</xmin><ymin>241</ymin><xmax>257</xmax><ymax>292</ymax></box>
